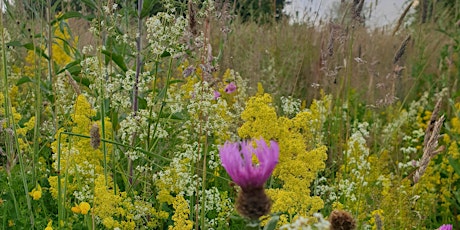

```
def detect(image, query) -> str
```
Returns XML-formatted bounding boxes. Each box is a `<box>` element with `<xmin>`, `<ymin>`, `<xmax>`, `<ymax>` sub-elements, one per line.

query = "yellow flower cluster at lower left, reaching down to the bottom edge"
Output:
<box><xmin>48</xmin><ymin>95</ymin><xmax>169</xmax><ymax>229</ymax></box>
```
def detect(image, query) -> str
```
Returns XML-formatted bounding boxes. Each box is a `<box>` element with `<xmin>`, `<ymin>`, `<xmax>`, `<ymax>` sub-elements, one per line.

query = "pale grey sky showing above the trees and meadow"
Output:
<box><xmin>285</xmin><ymin>0</ymin><xmax>409</xmax><ymax>26</ymax></box>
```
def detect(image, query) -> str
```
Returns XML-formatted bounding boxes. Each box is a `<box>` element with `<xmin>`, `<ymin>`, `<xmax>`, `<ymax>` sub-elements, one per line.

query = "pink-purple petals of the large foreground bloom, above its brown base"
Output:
<box><xmin>219</xmin><ymin>139</ymin><xmax>279</xmax><ymax>190</ymax></box>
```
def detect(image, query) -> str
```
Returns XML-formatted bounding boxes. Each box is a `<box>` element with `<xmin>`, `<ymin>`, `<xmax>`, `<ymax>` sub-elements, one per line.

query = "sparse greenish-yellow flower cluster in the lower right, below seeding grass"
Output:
<box><xmin>372</xmin><ymin>101</ymin><xmax>452</xmax><ymax>229</ymax></box>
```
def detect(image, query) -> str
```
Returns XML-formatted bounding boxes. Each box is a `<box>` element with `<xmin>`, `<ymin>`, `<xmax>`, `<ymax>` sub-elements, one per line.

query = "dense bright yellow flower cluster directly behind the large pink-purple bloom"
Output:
<box><xmin>238</xmin><ymin>93</ymin><xmax>329</xmax><ymax>224</ymax></box>
